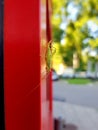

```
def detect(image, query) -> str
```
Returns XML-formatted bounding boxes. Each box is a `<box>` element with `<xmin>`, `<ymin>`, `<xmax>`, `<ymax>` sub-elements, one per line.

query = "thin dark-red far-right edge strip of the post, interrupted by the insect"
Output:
<box><xmin>46</xmin><ymin>0</ymin><xmax>53</xmax><ymax>130</ymax></box>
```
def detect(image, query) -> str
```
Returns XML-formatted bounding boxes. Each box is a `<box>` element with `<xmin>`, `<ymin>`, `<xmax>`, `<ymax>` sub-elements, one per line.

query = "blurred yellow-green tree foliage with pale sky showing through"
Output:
<box><xmin>52</xmin><ymin>0</ymin><xmax>98</xmax><ymax>70</ymax></box>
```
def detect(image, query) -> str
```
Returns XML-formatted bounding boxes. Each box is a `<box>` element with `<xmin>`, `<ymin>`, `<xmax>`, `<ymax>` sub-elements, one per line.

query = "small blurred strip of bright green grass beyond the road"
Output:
<box><xmin>67</xmin><ymin>78</ymin><xmax>91</xmax><ymax>84</ymax></box>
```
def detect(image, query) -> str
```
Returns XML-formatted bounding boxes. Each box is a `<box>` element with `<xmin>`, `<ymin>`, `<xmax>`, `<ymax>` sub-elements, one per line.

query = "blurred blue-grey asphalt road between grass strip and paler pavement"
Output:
<box><xmin>53</xmin><ymin>80</ymin><xmax>98</xmax><ymax>109</ymax></box>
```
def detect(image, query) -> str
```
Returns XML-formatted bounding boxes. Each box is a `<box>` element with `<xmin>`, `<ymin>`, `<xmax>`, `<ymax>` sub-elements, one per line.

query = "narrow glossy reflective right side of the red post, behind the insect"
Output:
<box><xmin>41</xmin><ymin>0</ymin><xmax>53</xmax><ymax>130</ymax></box>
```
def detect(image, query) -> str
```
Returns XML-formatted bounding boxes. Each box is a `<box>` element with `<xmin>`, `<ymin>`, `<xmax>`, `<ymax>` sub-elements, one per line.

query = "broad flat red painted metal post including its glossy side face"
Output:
<box><xmin>4</xmin><ymin>0</ymin><xmax>52</xmax><ymax>130</ymax></box>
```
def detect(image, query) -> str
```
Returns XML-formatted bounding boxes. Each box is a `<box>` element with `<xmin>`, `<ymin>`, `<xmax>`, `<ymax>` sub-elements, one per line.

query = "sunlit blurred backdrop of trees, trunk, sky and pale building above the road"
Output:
<box><xmin>52</xmin><ymin>0</ymin><xmax>98</xmax><ymax>78</ymax></box>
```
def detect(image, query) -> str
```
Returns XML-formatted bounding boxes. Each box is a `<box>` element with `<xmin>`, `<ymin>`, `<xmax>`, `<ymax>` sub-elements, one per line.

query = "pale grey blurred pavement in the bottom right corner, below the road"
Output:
<box><xmin>53</xmin><ymin>101</ymin><xmax>98</xmax><ymax>130</ymax></box>
